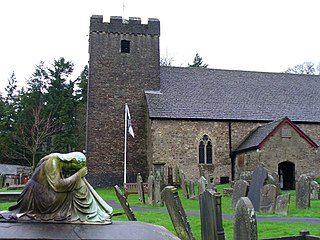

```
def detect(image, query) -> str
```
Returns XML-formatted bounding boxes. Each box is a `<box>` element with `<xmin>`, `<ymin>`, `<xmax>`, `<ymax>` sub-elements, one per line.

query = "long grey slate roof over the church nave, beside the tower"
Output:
<box><xmin>145</xmin><ymin>67</ymin><xmax>320</xmax><ymax>123</ymax></box>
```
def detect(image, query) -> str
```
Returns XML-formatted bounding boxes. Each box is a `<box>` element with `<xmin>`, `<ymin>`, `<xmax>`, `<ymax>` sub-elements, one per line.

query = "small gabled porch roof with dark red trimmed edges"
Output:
<box><xmin>235</xmin><ymin>117</ymin><xmax>319</xmax><ymax>153</ymax></box>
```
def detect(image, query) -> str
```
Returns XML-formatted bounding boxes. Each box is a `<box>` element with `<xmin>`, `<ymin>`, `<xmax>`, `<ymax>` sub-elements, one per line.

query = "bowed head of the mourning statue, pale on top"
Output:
<box><xmin>50</xmin><ymin>152</ymin><xmax>87</xmax><ymax>170</ymax></box>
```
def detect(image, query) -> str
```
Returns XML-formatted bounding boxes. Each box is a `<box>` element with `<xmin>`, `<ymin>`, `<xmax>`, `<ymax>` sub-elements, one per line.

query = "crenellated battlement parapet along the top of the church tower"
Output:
<box><xmin>90</xmin><ymin>15</ymin><xmax>160</xmax><ymax>36</ymax></box>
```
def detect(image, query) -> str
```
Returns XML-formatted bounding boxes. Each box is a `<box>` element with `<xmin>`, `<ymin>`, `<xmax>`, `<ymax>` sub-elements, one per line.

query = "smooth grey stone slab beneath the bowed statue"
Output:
<box><xmin>0</xmin><ymin>221</ymin><xmax>179</xmax><ymax>240</ymax></box>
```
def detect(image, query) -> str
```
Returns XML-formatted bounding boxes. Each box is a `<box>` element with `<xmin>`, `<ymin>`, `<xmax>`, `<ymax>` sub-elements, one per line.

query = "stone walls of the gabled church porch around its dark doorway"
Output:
<box><xmin>236</xmin><ymin>124</ymin><xmax>320</xmax><ymax>179</ymax></box>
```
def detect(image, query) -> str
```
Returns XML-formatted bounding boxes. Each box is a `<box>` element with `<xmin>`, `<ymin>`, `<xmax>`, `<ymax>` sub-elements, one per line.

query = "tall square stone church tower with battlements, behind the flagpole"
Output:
<box><xmin>86</xmin><ymin>15</ymin><xmax>160</xmax><ymax>187</ymax></box>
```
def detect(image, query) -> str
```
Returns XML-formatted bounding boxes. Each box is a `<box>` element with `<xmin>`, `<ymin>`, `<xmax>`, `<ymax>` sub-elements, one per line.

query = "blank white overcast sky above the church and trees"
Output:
<box><xmin>0</xmin><ymin>0</ymin><xmax>320</xmax><ymax>92</ymax></box>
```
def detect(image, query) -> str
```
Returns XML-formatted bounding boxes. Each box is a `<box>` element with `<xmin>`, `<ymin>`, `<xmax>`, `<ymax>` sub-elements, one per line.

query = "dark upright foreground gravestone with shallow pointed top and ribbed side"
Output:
<box><xmin>199</xmin><ymin>189</ymin><xmax>225</xmax><ymax>240</ymax></box>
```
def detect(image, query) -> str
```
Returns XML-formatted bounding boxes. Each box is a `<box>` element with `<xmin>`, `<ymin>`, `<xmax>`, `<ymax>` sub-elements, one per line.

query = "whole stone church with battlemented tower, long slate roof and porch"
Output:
<box><xmin>86</xmin><ymin>15</ymin><xmax>320</xmax><ymax>189</ymax></box>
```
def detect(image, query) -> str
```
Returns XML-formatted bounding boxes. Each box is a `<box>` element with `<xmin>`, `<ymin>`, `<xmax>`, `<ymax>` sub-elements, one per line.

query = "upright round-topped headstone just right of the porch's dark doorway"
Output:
<box><xmin>296</xmin><ymin>174</ymin><xmax>311</xmax><ymax>208</ymax></box>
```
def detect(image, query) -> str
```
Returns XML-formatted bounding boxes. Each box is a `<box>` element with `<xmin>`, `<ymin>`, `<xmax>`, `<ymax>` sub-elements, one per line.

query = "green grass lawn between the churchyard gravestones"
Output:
<box><xmin>0</xmin><ymin>185</ymin><xmax>320</xmax><ymax>240</ymax></box>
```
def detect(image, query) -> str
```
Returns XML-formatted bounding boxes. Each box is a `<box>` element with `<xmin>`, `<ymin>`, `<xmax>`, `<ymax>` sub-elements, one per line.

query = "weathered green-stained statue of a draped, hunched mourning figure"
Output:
<box><xmin>0</xmin><ymin>152</ymin><xmax>112</xmax><ymax>224</ymax></box>
